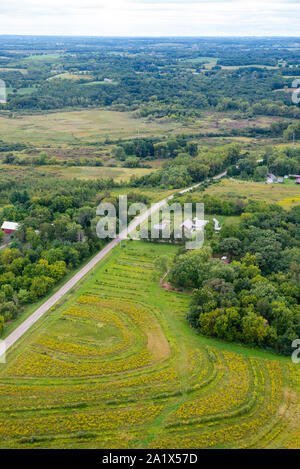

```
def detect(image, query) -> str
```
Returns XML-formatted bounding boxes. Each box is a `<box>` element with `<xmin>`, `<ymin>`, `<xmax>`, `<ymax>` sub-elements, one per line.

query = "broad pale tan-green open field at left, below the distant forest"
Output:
<box><xmin>0</xmin><ymin>109</ymin><xmax>178</xmax><ymax>146</ymax></box>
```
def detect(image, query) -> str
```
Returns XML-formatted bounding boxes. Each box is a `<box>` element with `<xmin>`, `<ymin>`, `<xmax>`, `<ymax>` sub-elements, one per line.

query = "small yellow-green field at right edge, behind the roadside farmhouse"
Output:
<box><xmin>205</xmin><ymin>179</ymin><xmax>300</xmax><ymax>208</ymax></box>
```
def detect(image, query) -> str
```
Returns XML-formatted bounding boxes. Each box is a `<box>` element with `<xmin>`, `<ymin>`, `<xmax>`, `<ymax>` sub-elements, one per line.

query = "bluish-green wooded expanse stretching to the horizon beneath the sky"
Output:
<box><xmin>0</xmin><ymin>36</ymin><xmax>300</xmax><ymax>119</ymax></box>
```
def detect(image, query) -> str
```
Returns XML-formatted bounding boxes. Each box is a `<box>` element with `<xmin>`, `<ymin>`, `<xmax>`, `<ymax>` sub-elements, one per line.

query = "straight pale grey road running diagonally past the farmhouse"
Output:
<box><xmin>1</xmin><ymin>173</ymin><xmax>226</xmax><ymax>353</ymax></box>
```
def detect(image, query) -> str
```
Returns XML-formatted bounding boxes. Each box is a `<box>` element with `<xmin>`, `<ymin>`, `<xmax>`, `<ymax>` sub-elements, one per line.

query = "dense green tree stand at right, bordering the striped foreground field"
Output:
<box><xmin>170</xmin><ymin>203</ymin><xmax>300</xmax><ymax>355</ymax></box>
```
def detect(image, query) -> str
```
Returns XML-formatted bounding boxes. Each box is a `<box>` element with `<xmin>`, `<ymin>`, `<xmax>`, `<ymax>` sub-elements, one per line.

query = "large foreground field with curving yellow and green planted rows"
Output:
<box><xmin>0</xmin><ymin>242</ymin><xmax>300</xmax><ymax>448</ymax></box>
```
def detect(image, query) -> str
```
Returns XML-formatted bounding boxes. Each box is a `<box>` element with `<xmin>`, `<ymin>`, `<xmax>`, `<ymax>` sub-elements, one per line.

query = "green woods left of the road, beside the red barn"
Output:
<box><xmin>0</xmin><ymin>178</ymin><xmax>125</xmax><ymax>333</ymax></box>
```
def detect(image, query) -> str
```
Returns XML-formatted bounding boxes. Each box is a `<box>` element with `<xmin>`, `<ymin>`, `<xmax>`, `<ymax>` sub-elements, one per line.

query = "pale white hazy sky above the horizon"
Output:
<box><xmin>0</xmin><ymin>0</ymin><xmax>300</xmax><ymax>36</ymax></box>
